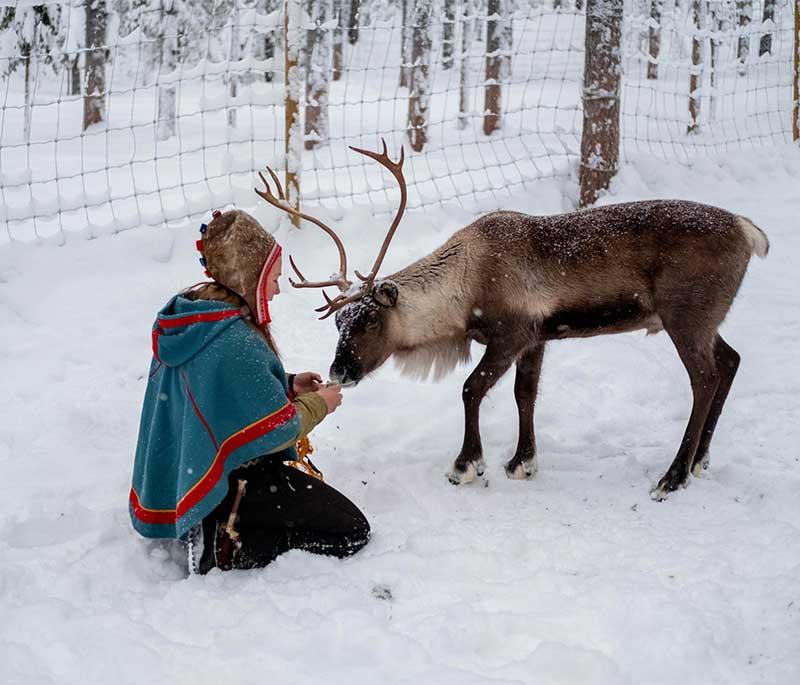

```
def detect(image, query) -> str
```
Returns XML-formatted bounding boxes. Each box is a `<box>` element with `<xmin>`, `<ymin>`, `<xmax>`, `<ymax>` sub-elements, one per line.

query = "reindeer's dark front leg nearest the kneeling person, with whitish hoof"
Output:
<box><xmin>447</xmin><ymin>340</ymin><xmax>518</xmax><ymax>485</ymax></box>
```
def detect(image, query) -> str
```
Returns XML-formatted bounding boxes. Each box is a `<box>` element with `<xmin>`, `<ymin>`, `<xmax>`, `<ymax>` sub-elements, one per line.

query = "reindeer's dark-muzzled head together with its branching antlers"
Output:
<box><xmin>256</xmin><ymin>140</ymin><xmax>407</xmax><ymax>385</ymax></box>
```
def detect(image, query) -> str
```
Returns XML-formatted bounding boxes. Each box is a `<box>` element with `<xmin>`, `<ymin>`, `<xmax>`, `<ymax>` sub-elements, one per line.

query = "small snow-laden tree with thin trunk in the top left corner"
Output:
<box><xmin>0</xmin><ymin>3</ymin><xmax>61</xmax><ymax>140</ymax></box>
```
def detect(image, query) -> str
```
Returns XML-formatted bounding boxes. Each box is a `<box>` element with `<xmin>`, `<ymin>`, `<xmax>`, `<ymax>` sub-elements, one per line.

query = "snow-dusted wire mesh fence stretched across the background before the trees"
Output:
<box><xmin>0</xmin><ymin>0</ymin><xmax>794</xmax><ymax>240</ymax></box>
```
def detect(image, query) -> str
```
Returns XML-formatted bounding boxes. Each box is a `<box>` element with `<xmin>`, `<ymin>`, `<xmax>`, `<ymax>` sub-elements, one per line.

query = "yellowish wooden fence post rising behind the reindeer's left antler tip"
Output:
<box><xmin>283</xmin><ymin>0</ymin><xmax>303</xmax><ymax>227</ymax></box>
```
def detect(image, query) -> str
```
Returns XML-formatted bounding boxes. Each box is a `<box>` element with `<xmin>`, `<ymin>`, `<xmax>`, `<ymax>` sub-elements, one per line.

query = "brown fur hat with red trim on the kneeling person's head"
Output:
<box><xmin>202</xmin><ymin>209</ymin><xmax>281</xmax><ymax>324</ymax></box>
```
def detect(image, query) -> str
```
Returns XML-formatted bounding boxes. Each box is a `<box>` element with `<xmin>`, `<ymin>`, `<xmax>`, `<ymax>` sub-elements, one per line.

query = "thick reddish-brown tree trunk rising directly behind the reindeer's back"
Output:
<box><xmin>580</xmin><ymin>0</ymin><xmax>623</xmax><ymax>207</ymax></box>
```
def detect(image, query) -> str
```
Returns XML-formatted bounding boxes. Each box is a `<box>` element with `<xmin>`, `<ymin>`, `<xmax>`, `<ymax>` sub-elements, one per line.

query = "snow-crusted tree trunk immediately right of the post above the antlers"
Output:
<box><xmin>304</xmin><ymin>0</ymin><xmax>331</xmax><ymax>150</ymax></box>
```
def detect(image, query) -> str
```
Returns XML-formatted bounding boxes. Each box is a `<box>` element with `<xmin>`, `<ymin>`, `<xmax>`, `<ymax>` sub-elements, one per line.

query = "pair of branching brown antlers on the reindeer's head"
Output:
<box><xmin>255</xmin><ymin>138</ymin><xmax>407</xmax><ymax>319</ymax></box>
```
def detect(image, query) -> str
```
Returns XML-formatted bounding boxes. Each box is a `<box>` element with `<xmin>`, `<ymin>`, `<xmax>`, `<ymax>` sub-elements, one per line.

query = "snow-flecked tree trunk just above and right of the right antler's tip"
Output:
<box><xmin>408</xmin><ymin>0</ymin><xmax>432</xmax><ymax>152</ymax></box>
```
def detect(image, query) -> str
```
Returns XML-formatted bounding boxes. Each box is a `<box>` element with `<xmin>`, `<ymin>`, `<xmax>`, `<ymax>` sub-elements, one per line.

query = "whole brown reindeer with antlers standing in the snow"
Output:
<box><xmin>256</xmin><ymin>141</ymin><xmax>769</xmax><ymax>500</ymax></box>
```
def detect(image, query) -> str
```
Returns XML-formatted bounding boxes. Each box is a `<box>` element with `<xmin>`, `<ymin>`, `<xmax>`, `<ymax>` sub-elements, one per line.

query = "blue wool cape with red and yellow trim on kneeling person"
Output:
<box><xmin>129</xmin><ymin>295</ymin><xmax>300</xmax><ymax>538</ymax></box>
